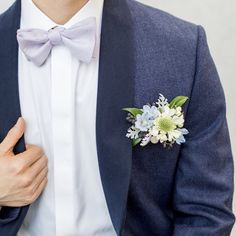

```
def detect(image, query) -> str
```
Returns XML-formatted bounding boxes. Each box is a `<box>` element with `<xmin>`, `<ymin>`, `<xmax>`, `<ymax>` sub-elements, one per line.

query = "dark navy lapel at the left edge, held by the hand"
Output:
<box><xmin>0</xmin><ymin>1</ymin><xmax>24</xmax><ymax>152</ymax></box>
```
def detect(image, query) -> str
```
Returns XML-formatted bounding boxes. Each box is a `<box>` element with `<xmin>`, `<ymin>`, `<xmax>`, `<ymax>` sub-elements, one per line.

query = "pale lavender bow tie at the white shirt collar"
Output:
<box><xmin>17</xmin><ymin>17</ymin><xmax>96</xmax><ymax>66</ymax></box>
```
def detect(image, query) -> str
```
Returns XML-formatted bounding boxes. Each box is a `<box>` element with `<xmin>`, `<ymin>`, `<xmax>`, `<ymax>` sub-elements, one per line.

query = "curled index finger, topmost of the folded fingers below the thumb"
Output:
<box><xmin>15</xmin><ymin>145</ymin><xmax>44</xmax><ymax>171</ymax></box>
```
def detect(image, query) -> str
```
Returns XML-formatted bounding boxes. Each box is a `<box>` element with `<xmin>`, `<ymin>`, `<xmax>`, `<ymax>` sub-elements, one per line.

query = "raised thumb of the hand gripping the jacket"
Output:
<box><xmin>0</xmin><ymin>117</ymin><xmax>25</xmax><ymax>155</ymax></box>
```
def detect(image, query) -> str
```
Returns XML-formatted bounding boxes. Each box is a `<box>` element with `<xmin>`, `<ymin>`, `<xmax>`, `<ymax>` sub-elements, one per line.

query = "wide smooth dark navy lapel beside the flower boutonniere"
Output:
<box><xmin>97</xmin><ymin>0</ymin><xmax>134</xmax><ymax>235</ymax></box>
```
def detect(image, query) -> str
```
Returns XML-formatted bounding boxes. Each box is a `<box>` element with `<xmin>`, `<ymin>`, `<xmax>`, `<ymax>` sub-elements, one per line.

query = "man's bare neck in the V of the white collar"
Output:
<box><xmin>33</xmin><ymin>0</ymin><xmax>89</xmax><ymax>25</ymax></box>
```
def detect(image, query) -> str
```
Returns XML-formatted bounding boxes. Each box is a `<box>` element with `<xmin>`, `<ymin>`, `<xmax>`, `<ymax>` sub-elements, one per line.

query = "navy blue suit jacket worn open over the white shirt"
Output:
<box><xmin>0</xmin><ymin>0</ymin><xmax>234</xmax><ymax>236</ymax></box>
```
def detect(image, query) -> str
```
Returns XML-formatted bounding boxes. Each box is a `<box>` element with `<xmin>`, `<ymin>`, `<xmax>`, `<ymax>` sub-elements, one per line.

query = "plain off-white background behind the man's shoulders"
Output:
<box><xmin>0</xmin><ymin>0</ymin><xmax>236</xmax><ymax>236</ymax></box>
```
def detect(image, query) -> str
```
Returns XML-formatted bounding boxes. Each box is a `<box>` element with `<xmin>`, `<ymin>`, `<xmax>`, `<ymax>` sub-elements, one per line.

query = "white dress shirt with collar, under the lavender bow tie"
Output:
<box><xmin>18</xmin><ymin>0</ymin><xmax>116</xmax><ymax>236</ymax></box>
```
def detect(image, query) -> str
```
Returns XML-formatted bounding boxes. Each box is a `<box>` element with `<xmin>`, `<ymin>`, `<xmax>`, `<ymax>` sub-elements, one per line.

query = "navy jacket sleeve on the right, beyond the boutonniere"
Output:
<box><xmin>173</xmin><ymin>26</ymin><xmax>234</xmax><ymax>236</ymax></box>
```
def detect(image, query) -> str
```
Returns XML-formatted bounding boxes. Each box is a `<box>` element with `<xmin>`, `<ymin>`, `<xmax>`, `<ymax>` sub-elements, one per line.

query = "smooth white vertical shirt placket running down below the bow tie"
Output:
<box><xmin>51</xmin><ymin>46</ymin><xmax>74</xmax><ymax>236</ymax></box>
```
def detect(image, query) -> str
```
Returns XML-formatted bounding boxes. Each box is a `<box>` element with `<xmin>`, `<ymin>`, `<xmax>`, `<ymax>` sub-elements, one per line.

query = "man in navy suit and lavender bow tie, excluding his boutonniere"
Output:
<box><xmin>0</xmin><ymin>0</ymin><xmax>234</xmax><ymax>236</ymax></box>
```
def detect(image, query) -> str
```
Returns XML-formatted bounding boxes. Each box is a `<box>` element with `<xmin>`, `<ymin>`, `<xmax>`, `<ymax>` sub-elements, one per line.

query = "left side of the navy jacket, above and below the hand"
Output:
<box><xmin>0</xmin><ymin>2</ymin><xmax>28</xmax><ymax>236</ymax></box>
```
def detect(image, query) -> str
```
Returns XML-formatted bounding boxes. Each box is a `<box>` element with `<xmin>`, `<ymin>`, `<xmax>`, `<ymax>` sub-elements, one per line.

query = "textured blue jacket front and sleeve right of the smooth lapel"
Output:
<box><xmin>123</xmin><ymin>1</ymin><xmax>234</xmax><ymax>236</ymax></box>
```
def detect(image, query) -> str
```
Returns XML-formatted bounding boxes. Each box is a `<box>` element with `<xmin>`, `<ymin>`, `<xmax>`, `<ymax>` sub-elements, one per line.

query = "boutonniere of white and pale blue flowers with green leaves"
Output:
<box><xmin>123</xmin><ymin>94</ymin><xmax>189</xmax><ymax>147</ymax></box>
